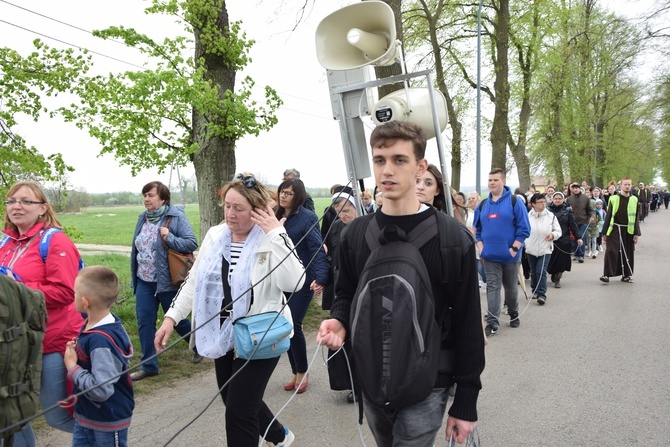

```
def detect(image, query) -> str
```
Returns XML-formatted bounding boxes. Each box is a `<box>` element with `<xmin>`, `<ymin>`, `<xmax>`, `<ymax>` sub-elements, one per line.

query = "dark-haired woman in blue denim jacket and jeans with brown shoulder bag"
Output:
<box><xmin>130</xmin><ymin>181</ymin><xmax>202</xmax><ymax>381</ymax></box>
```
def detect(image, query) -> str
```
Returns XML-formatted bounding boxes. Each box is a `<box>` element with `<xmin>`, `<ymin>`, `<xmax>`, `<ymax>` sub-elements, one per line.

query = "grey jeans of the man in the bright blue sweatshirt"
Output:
<box><xmin>484</xmin><ymin>259</ymin><xmax>521</xmax><ymax>328</ymax></box>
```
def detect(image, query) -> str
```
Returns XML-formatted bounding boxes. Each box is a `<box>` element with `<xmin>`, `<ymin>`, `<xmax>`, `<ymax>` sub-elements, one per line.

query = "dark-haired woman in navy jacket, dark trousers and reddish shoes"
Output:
<box><xmin>276</xmin><ymin>178</ymin><xmax>328</xmax><ymax>394</ymax></box>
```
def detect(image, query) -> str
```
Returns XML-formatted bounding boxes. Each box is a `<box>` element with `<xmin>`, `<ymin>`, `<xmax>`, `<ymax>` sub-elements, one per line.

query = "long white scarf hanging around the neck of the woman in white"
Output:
<box><xmin>193</xmin><ymin>225</ymin><xmax>265</xmax><ymax>359</ymax></box>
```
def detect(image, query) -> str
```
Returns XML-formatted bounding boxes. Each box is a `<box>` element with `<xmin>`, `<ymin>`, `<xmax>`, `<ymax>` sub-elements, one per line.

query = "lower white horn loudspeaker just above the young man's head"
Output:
<box><xmin>372</xmin><ymin>87</ymin><xmax>447</xmax><ymax>139</ymax></box>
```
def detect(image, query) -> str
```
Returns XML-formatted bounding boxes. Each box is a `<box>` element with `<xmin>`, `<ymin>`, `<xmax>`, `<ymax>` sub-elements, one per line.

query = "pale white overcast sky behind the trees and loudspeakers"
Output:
<box><xmin>0</xmin><ymin>0</ymin><xmax>660</xmax><ymax>193</ymax></box>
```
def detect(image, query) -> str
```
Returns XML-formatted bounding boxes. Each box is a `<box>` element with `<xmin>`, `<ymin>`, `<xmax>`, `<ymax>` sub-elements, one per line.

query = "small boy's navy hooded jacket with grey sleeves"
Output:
<box><xmin>67</xmin><ymin>316</ymin><xmax>135</xmax><ymax>432</ymax></box>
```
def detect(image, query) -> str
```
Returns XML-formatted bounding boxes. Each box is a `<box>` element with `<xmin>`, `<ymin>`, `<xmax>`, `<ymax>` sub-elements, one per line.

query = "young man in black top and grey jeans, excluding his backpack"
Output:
<box><xmin>317</xmin><ymin>121</ymin><xmax>484</xmax><ymax>447</ymax></box>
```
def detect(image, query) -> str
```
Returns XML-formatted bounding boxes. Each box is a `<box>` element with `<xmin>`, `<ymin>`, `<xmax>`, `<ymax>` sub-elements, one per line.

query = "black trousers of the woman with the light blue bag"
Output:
<box><xmin>214</xmin><ymin>351</ymin><xmax>285</xmax><ymax>447</ymax></box>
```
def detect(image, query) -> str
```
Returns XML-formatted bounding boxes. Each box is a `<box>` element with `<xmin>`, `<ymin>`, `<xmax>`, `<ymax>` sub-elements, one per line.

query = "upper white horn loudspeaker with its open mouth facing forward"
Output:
<box><xmin>316</xmin><ymin>0</ymin><xmax>397</xmax><ymax>70</ymax></box>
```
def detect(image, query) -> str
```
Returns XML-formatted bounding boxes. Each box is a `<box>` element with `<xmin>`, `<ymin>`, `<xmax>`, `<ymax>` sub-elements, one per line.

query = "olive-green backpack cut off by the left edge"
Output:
<box><xmin>0</xmin><ymin>273</ymin><xmax>47</xmax><ymax>446</ymax></box>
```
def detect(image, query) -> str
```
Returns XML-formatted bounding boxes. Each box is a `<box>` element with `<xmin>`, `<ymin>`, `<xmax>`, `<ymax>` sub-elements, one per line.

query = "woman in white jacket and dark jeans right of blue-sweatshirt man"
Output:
<box><xmin>525</xmin><ymin>193</ymin><xmax>561</xmax><ymax>304</ymax></box>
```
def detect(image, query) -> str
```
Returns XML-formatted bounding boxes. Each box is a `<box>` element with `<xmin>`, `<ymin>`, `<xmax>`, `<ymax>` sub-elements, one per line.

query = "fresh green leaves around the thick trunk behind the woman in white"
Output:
<box><xmin>60</xmin><ymin>0</ymin><xmax>282</xmax><ymax>178</ymax></box>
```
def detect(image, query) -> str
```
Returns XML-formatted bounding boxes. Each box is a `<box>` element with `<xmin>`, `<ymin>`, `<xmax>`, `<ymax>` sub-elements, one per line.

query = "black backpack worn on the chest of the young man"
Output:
<box><xmin>350</xmin><ymin>213</ymin><xmax>463</xmax><ymax>409</ymax></box>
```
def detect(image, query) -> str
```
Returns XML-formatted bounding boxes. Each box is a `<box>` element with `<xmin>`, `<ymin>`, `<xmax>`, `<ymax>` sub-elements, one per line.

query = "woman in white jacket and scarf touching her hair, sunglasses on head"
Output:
<box><xmin>154</xmin><ymin>173</ymin><xmax>305</xmax><ymax>447</ymax></box>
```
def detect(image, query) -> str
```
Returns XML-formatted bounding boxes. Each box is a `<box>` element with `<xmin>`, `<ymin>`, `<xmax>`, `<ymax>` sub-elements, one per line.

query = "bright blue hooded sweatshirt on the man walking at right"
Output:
<box><xmin>473</xmin><ymin>186</ymin><xmax>530</xmax><ymax>264</ymax></box>
